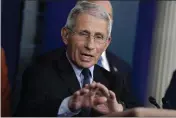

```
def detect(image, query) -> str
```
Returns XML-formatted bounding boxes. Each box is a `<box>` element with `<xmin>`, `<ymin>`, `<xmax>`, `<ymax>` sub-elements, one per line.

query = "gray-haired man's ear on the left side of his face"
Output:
<box><xmin>61</xmin><ymin>27</ymin><xmax>69</xmax><ymax>45</ymax></box>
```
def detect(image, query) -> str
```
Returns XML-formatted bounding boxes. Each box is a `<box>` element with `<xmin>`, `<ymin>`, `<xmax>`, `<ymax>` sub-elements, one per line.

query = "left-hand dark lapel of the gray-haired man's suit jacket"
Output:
<box><xmin>54</xmin><ymin>51</ymin><xmax>80</xmax><ymax>94</ymax></box>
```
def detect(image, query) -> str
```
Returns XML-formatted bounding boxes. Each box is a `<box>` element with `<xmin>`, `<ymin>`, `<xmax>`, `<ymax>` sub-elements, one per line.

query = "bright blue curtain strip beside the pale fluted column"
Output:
<box><xmin>132</xmin><ymin>0</ymin><xmax>156</xmax><ymax>105</ymax></box>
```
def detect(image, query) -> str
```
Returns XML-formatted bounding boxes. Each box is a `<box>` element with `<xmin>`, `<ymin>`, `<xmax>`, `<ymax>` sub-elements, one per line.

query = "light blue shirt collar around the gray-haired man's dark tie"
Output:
<box><xmin>66</xmin><ymin>52</ymin><xmax>94</xmax><ymax>78</ymax></box>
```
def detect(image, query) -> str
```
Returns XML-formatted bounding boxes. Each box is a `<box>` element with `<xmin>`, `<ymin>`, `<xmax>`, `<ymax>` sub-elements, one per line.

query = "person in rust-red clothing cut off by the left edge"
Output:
<box><xmin>1</xmin><ymin>48</ymin><xmax>11</xmax><ymax>117</ymax></box>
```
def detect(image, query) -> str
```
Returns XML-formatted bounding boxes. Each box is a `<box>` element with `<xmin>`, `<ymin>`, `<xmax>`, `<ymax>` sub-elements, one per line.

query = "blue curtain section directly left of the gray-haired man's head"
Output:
<box><xmin>41</xmin><ymin>0</ymin><xmax>76</xmax><ymax>53</ymax></box>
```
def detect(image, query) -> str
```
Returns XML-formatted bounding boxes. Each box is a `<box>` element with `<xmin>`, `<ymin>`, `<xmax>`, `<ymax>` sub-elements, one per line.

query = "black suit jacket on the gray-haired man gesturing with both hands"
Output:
<box><xmin>16</xmin><ymin>49</ymin><xmax>140</xmax><ymax>116</ymax></box>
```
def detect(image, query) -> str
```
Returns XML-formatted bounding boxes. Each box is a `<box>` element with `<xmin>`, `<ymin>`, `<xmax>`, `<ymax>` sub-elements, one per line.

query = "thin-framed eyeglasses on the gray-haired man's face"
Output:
<box><xmin>67</xmin><ymin>28</ymin><xmax>108</xmax><ymax>44</ymax></box>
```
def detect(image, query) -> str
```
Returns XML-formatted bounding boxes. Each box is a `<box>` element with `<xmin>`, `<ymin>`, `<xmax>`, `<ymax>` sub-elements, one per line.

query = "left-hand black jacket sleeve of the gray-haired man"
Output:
<box><xmin>15</xmin><ymin>66</ymin><xmax>66</xmax><ymax>117</ymax></box>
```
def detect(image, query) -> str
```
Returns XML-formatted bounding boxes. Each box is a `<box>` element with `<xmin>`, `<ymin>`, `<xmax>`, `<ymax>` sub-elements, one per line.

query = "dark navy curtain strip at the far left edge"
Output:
<box><xmin>1</xmin><ymin>0</ymin><xmax>23</xmax><ymax>90</ymax></box>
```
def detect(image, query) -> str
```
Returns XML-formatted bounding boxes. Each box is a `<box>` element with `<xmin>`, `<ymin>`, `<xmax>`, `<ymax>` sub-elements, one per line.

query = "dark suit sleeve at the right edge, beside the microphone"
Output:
<box><xmin>163</xmin><ymin>71</ymin><xmax>176</xmax><ymax>109</ymax></box>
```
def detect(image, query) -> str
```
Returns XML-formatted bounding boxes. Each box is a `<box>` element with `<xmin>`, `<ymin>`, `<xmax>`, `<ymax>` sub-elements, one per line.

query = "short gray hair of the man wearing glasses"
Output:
<box><xmin>65</xmin><ymin>1</ymin><xmax>112</xmax><ymax>37</ymax></box>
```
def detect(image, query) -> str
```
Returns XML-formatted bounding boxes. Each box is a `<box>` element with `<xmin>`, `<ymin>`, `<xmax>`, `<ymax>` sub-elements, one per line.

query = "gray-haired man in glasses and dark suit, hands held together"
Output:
<box><xmin>16</xmin><ymin>2</ymin><xmax>139</xmax><ymax>116</ymax></box>
